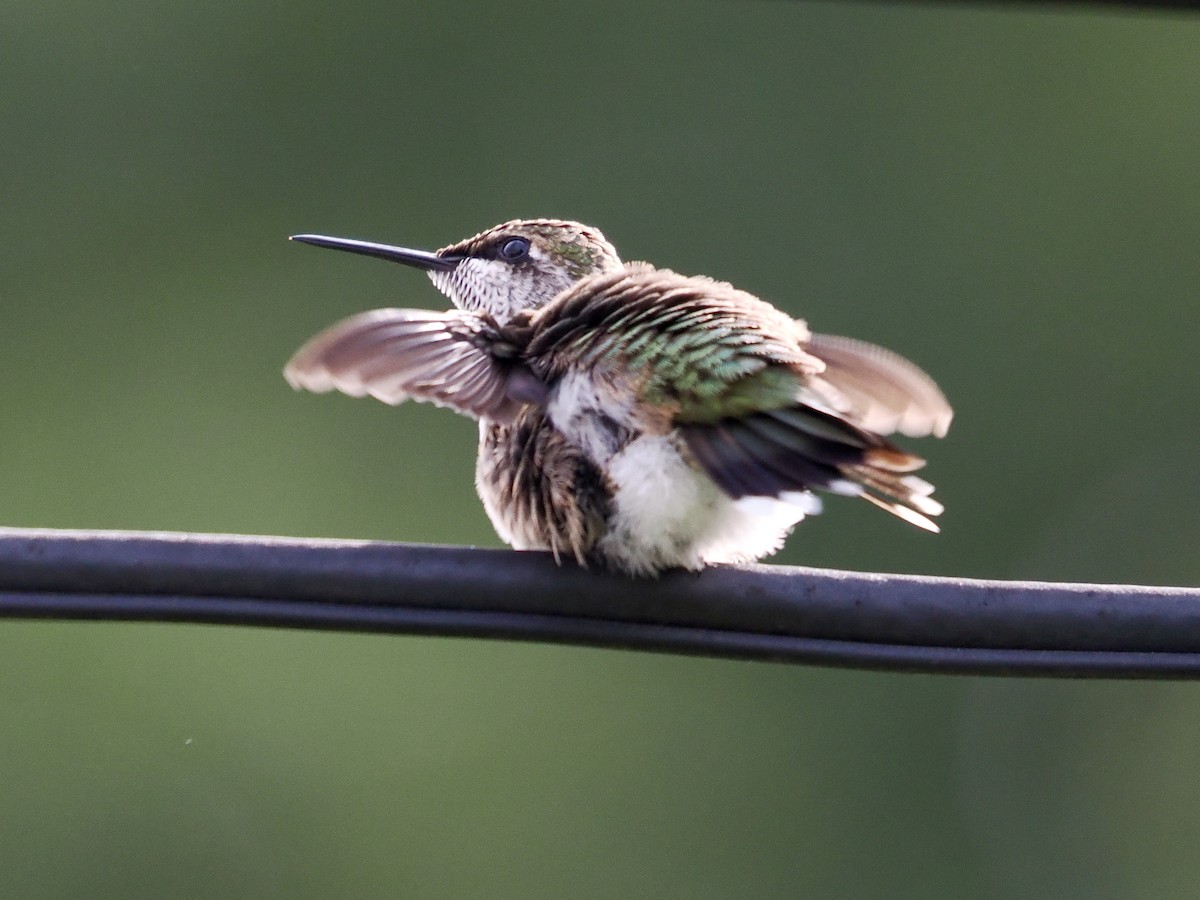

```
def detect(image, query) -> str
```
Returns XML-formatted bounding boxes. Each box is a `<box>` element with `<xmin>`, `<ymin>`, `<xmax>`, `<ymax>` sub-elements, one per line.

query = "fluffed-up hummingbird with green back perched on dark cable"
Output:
<box><xmin>284</xmin><ymin>218</ymin><xmax>953</xmax><ymax>576</ymax></box>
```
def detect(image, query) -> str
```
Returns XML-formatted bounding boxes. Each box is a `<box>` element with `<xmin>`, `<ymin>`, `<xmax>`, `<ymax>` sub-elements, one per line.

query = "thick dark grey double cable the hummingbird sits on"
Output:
<box><xmin>0</xmin><ymin>529</ymin><xmax>1200</xmax><ymax>678</ymax></box>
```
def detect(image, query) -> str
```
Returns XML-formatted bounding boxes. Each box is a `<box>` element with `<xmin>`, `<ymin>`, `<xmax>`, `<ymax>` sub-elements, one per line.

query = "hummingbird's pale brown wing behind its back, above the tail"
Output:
<box><xmin>805</xmin><ymin>335</ymin><xmax>954</xmax><ymax>438</ymax></box>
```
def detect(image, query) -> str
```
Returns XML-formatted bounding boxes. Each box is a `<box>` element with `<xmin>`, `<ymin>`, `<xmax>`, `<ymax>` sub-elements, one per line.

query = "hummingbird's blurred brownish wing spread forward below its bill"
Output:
<box><xmin>283</xmin><ymin>310</ymin><xmax>545</xmax><ymax>421</ymax></box>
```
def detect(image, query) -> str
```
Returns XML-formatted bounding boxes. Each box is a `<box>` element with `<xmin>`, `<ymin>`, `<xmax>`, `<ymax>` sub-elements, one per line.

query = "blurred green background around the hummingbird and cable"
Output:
<box><xmin>0</xmin><ymin>0</ymin><xmax>1200</xmax><ymax>899</ymax></box>
